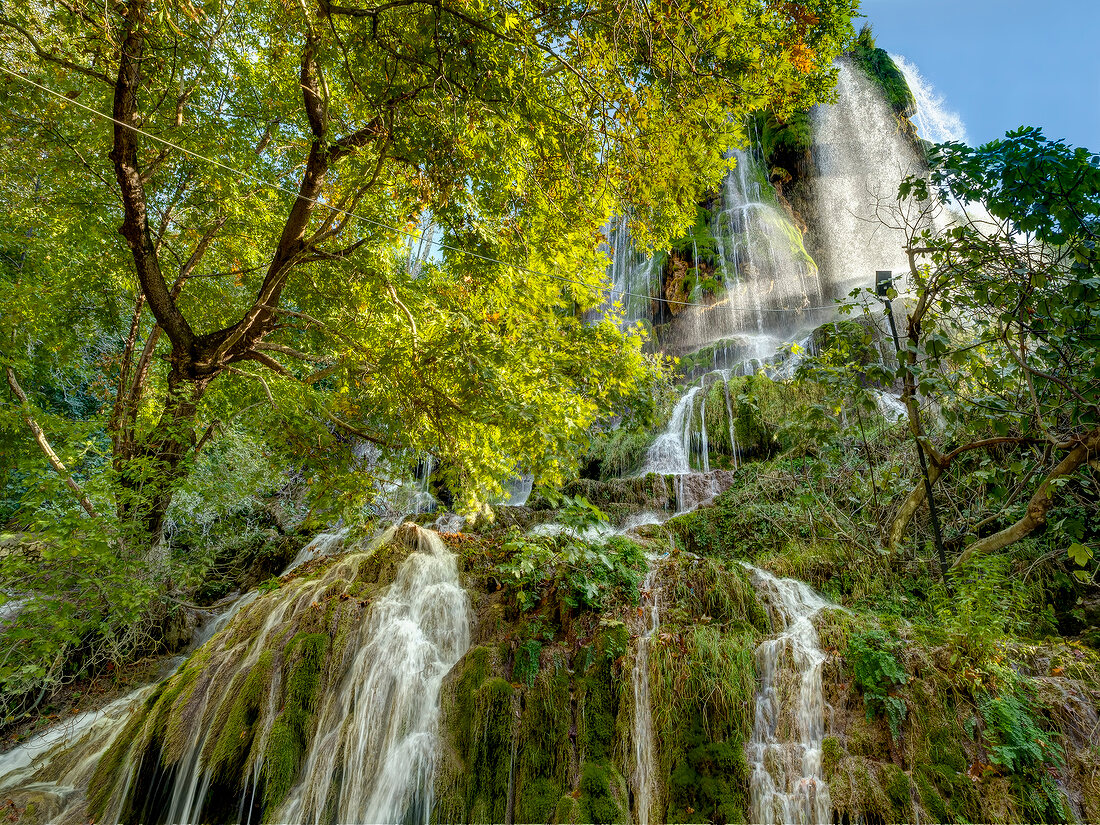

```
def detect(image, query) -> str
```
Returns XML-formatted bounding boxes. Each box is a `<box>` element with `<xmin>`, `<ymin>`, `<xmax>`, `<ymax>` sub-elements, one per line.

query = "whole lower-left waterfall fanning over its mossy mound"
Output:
<box><xmin>0</xmin><ymin>525</ymin><xmax>471</xmax><ymax>825</ymax></box>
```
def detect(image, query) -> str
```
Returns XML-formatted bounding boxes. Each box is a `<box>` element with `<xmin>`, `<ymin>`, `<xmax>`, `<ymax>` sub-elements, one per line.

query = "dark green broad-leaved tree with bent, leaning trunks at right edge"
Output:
<box><xmin>891</xmin><ymin>129</ymin><xmax>1100</xmax><ymax>567</ymax></box>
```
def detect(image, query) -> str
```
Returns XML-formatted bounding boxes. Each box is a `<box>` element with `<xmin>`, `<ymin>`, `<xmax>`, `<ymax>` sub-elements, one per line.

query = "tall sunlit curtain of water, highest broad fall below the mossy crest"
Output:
<box><xmin>813</xmin><ymin>59</ymin><xmax>924</xmax><ymax>297</ymax></box>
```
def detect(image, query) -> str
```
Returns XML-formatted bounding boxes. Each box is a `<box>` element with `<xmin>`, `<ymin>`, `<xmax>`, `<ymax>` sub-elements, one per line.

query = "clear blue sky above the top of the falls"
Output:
<box><xmin>856</xmin><ymin>0</ymin><xmax>1100</xmax><ymax>151</ymax></box>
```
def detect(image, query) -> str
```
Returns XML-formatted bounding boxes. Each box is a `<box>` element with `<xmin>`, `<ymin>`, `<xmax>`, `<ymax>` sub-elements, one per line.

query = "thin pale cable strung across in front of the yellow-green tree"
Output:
<box><xmin>0</xmin><ymin>65</ymin><xmax>835</xmax><ymax>312</ymax></box>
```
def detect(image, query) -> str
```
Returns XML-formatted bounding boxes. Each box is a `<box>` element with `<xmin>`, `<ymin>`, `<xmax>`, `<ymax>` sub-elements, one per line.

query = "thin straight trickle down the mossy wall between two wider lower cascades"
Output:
<box><xmin>630</xmin><ymin>558</ymin><xmax>660</xmax><ymax>825</ymax></box>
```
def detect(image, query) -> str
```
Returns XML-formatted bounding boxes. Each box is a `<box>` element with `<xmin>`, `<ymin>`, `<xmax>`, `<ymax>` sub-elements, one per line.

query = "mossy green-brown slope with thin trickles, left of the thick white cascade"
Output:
<box><xmin>88</xmin><ymin>526</ymin><xmax>418</xmax><ymax>823</ymax></box>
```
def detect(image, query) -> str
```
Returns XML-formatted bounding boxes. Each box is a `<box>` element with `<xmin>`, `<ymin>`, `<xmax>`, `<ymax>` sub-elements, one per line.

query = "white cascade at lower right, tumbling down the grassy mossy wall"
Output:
<box><xmin>745</xmin><ymin>565</ymin><xmax>833</xmax><ymax>825</ymax></box>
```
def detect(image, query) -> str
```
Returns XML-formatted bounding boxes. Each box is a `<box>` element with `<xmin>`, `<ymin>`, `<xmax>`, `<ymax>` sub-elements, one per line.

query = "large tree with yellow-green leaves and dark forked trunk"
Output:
<box><xmin>0</xmin><ymin>0</ymin><xmax>854</xmax><ymax>543</ymax></box>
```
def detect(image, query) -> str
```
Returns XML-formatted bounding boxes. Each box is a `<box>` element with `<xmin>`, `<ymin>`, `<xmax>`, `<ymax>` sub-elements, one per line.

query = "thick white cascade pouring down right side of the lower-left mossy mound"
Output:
<box><xmin>278</xmin><ymin>530</ymin><xmax>470</xmax><ymax>823</ymax></box>
